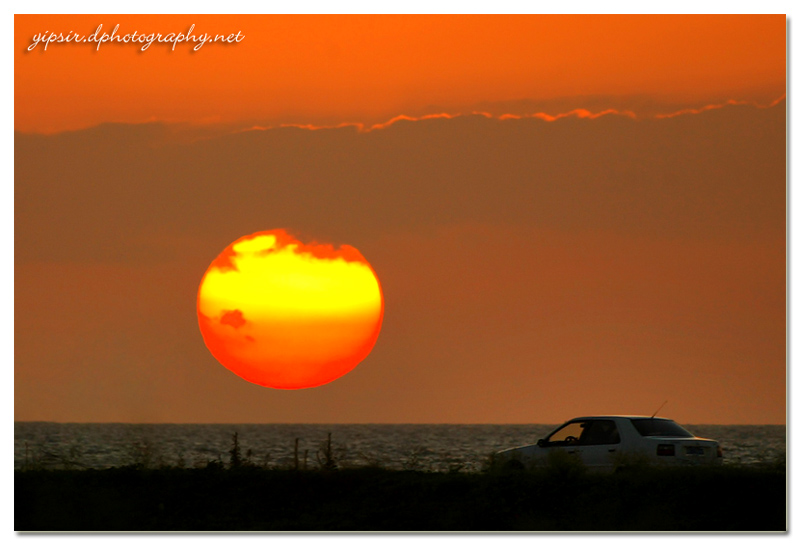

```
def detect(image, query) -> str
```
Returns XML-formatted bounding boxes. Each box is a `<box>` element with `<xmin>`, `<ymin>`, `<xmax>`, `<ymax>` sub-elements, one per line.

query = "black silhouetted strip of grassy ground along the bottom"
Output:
<box><xmin>14</xmin><ymin>462</ymin><xmax>787</xmax><ymax>531</ymax></box>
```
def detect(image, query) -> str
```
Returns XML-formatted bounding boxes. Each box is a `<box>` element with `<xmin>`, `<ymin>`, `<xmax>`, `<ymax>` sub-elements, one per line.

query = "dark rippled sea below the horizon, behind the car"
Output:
<box><xmin>14</xmin><ymin>422</ymin><xmax>786</xmax><ymax>472</ymax></box>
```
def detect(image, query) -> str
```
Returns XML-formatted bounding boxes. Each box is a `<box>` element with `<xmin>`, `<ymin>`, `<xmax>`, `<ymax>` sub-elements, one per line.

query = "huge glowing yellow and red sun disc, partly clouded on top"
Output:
<box><xmin>197</xmin><ymin>229</ymin><xmax>383</xmax><ymax>389</ymax></box>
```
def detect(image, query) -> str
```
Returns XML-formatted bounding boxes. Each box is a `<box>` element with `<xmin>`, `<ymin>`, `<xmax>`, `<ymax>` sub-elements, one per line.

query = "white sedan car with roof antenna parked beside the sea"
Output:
<box><xmin>494</xmin><ymin>416</ymin><xmax>722</xmax><ymax>471</ymax></box>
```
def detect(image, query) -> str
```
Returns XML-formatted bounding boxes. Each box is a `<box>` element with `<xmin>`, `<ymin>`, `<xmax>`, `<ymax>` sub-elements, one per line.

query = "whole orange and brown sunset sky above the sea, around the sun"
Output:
<box><xmin>14</xmin><ymin>11</ymin><xmax>787</xmax><ymax>424</ymax></box>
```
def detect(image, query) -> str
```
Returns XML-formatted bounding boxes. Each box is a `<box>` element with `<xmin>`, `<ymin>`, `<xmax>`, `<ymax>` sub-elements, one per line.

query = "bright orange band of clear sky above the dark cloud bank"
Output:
<box><xmin>14</xmin><ymin>15</ymin><xmax>785</xmax><ymax>132</ymax></box>
